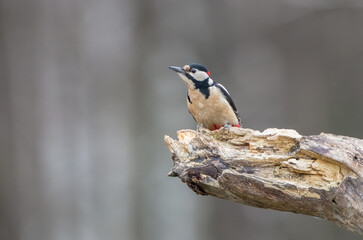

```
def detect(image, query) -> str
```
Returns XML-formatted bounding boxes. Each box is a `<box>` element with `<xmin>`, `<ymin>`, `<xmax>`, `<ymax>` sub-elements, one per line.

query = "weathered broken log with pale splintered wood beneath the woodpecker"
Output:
<box><xmin>165</xmin><ymin>128</ymin><xmax>363</xmax><ymax>235</ymax></box>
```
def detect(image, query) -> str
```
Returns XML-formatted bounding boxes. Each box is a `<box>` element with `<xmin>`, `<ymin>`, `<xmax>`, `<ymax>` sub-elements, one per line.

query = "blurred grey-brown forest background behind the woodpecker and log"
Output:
<box><xmin>0</xmin><ymin>0</ymin><xmax>363</xmax><ymax>240</ymax></box>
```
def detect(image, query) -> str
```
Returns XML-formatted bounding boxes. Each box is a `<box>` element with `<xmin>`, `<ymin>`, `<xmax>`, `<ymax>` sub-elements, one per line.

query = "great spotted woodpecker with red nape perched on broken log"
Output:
<box><xmin>169</xmin><ymin>63</ymin><xmax>242</xmax><ymax>130</ymax></box>
